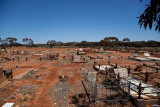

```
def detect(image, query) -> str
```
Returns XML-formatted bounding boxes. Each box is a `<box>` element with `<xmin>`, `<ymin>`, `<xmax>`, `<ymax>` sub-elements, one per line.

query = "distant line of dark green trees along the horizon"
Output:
<box><xmin>0</xmin><ymin>37</ymin><xmax>160</xmax><ymax>48</ymax></box>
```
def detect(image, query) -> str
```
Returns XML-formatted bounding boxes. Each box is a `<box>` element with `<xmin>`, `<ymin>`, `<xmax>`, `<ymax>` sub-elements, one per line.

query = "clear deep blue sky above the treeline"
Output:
<box><xmin>0</xmin><ymin>0</ymin><xmax>160</xmax><ymax>43</ymax></box>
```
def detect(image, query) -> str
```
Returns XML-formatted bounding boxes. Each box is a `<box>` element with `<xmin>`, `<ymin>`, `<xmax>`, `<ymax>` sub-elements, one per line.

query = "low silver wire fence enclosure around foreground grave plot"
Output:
<box><xmin>84</xmin><ymin>71</ymin><xmax>130</xmax><ymax>102</ymax></box>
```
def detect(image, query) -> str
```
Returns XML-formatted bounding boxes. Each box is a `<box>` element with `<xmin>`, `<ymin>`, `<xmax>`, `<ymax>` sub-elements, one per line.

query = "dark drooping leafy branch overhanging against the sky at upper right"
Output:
<box><xmin>138</xmin><ymin>0</ymin><xmax>160</xmax><ymax>33</ymax></box>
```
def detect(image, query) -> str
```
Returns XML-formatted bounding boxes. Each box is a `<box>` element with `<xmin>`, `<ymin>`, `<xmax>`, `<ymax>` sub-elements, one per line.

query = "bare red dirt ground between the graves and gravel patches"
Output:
<box><xmin>0</xmin><ymin>47</ymin><xmax>159</xmax><ymax>107</ymax></box>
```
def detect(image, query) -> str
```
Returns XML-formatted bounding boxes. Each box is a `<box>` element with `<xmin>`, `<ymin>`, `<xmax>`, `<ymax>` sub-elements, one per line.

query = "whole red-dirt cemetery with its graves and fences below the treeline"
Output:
<box><xmin>0</xmin><ymin>47</ymin><xmax>160</xmax><ymax>107</ymax></box>
